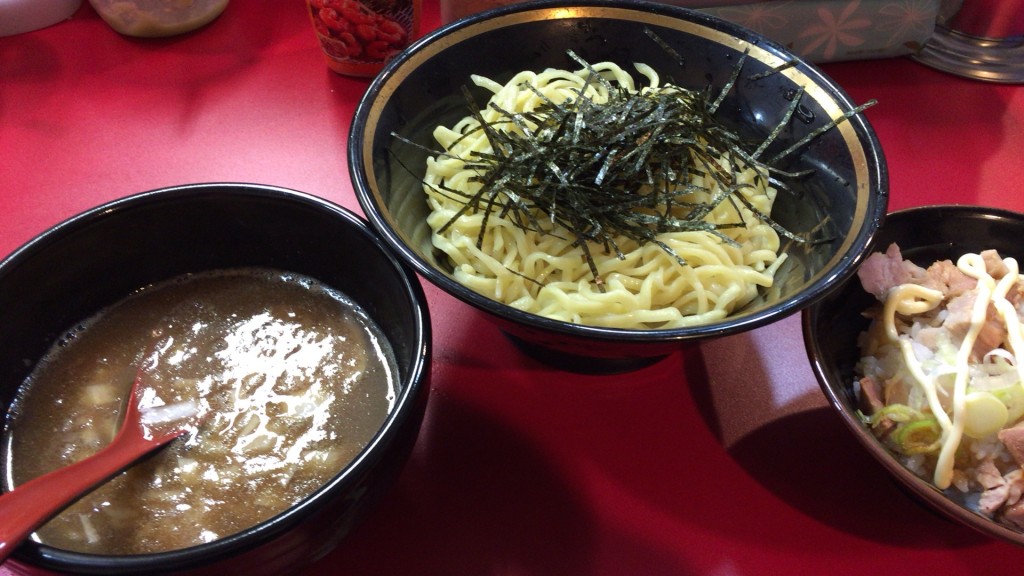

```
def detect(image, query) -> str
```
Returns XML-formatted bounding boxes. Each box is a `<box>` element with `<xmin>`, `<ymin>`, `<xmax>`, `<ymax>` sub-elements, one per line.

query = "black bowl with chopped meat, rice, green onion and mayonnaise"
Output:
<box><xmin>802</xmin><ymin>205</ymin><xmax>1024</xmax><ymax>544</ymax></box>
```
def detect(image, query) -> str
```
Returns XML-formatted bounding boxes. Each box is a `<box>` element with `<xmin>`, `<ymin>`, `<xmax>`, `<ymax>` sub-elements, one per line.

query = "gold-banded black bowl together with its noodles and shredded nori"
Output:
<box><xmin>348</xmin><ymin>1</ymin><xmax>888</xmax><ymax>371</ymax></box>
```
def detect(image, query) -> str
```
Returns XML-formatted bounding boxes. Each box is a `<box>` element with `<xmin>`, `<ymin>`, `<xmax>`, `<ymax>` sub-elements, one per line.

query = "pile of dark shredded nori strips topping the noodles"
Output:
<box><xmin>392</xmin><ymin>31</ymin><xmax>874</xmax><ymax>290</ymax></box>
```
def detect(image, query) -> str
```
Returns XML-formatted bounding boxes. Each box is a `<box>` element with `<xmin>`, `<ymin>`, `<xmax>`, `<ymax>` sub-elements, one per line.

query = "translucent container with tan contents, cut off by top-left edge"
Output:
<box><xmin>89</xmin><ymin>0</ymin><xmax>227</xmax><ymax>38</ymax></box>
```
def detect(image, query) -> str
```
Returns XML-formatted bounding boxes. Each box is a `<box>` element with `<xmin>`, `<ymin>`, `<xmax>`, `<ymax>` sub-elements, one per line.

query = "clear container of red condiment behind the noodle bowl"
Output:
<box><xmin>306</xmin><ymin>0</ymin><xmax>421</xmax><ymax>77</ymax></box>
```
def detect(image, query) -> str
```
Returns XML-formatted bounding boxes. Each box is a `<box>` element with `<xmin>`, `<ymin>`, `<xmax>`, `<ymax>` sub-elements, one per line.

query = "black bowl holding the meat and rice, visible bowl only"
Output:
<box><xmin>802</xmin><ymin>206</ymin><xmax>1024</xmax><ymax>544</ymax></box>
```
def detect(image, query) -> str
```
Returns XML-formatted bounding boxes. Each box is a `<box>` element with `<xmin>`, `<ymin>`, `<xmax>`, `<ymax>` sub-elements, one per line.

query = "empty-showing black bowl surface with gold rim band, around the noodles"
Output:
<box><xmin>348</xmin><ymin>1</ymin><xmax>888</xmax><ymax>369</ymax></box>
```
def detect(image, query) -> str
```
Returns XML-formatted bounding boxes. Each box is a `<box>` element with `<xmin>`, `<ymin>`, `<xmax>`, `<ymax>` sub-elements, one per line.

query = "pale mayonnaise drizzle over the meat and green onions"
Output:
<box><xmin>883</xmin><ymin>254</ymin><xmax>1024</xmax><ymax>489</ymax></box>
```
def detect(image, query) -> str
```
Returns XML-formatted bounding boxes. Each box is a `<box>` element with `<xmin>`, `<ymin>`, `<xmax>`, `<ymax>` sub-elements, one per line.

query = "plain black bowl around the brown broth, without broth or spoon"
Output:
<box><xmin>0</xmin><ymin>183</ymin><xmax>430</xmax><ymax>574</ymax></box>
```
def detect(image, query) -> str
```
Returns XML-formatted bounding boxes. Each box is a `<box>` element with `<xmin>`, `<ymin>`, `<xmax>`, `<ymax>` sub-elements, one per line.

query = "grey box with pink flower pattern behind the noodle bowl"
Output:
<box><xmin>662</xmin><ymin>0</ymin><xmax>942</xmax><ymax>63</ymax></box>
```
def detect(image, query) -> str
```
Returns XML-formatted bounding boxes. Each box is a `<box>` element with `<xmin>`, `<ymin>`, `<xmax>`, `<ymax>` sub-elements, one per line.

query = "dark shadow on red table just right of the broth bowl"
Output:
<box><xmin>319</xmin><ymin>356</ymin><xmax>593</xmax><ymax>575</ymax></box>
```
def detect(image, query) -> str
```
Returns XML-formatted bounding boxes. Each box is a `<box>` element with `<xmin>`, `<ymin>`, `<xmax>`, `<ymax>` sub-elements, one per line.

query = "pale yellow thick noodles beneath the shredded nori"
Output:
<box><xmin>423</xmin><ymin>63</ymin><xmax>784</xmax><ymax>329</ymax></box>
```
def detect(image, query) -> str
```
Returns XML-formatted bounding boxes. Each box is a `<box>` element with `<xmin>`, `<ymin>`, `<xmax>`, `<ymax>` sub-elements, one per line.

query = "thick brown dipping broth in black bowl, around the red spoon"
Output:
<box><xmin>4</xmin><ymin>269</ymin><xmax>394</xmax><ymax>554</ymax></box>
